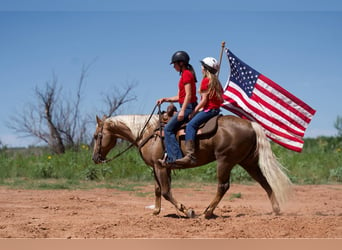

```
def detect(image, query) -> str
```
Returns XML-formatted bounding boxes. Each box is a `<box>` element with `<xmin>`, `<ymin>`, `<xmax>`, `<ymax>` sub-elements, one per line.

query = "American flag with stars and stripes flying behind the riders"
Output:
<box><xmin>222</xmin><ymin>49</ymin><xmax>316</xmax><ymax>152</ymax></box>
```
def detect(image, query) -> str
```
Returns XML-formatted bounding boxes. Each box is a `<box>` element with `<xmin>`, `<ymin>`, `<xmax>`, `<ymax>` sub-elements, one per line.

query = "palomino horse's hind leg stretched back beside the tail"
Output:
<box><xmin>241</xmin><ymin>159</ymin><xmax>280</xmax><ymax>214</ymax></box>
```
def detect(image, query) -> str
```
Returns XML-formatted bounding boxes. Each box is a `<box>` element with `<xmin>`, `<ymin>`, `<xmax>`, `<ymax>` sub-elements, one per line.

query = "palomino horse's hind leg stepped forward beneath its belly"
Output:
<box><xmin>204</xmin><ymin>159</ymin><xmax>233</xmax><ymax>219</ymax></box>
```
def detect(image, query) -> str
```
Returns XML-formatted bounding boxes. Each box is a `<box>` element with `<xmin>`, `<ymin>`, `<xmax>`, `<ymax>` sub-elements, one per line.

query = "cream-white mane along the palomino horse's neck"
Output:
<box><xmin>106</xmin><ymin>115</ymin><xmax>158</xmax><ymax>137</ymax></box>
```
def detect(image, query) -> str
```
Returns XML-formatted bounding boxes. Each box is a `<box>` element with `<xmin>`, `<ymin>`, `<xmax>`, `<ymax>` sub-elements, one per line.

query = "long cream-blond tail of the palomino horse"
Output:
<box><xmin>252</xmin><ymin>122</ymin><xmax>292</xmax><ymax>204</ymax></box>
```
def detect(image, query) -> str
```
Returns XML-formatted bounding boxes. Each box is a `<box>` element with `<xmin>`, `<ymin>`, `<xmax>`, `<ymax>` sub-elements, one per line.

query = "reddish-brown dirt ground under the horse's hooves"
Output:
<box><xmin>0</xmin><ymin>184</ymin><xmax>342</xmax><ymax>239</ymax></box>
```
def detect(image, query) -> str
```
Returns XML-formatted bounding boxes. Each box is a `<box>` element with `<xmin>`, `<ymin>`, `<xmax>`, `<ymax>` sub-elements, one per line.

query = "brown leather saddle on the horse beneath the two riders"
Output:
<box><xmin>158</xmin><ymin>105</ymin><xmax>222</xmax><ymax>140</ymax></box>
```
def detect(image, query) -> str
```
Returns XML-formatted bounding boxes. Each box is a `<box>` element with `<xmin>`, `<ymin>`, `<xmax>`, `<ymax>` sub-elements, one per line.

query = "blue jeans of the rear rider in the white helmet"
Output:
<box><xmin>185</xmin><ymin>109</ymin><xmax>220</xmax><ymax>141</ymax></box>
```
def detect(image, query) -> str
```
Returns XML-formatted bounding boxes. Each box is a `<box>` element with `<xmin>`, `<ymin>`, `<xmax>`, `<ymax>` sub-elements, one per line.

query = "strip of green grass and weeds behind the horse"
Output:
<box><xmin>0</xmin><ymin>137</ymin><xmax>342</xmax><ymax>189</ymax></box>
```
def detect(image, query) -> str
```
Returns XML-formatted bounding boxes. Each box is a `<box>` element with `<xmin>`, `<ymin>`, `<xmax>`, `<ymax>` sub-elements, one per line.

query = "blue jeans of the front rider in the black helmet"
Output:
<box><xmin>164</xmin><ymin>103</ymin><xmax>197</xmax><ymax>163</ymax></box>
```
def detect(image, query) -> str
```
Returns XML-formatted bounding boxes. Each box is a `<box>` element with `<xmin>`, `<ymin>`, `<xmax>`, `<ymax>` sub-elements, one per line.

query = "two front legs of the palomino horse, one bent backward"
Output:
<box><xmin>155</xmin><ymin>167</ymin><xmax>195</xmax><ymax>218</ymax></box>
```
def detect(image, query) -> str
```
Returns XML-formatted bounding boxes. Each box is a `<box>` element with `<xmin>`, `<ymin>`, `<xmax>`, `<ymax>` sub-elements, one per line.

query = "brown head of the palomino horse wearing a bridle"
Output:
<box><xmin>93</xmin><ymin>116</ymin><xmax>117</xmax><ymax>164</ymax></box>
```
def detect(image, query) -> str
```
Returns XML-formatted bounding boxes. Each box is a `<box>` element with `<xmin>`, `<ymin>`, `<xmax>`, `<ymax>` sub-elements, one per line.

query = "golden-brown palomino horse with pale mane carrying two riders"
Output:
<box><xmin>93</xmin><ymin>112</ymin><xmax>291</xmax><ymax>218</ymax></box>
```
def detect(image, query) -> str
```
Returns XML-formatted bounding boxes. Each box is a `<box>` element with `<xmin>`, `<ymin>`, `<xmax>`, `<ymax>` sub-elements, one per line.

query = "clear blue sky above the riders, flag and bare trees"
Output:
<box><xmin>0</xmin><ymin>0</ymin><xmax>342</xmax><ymax>146</ymax></box>
